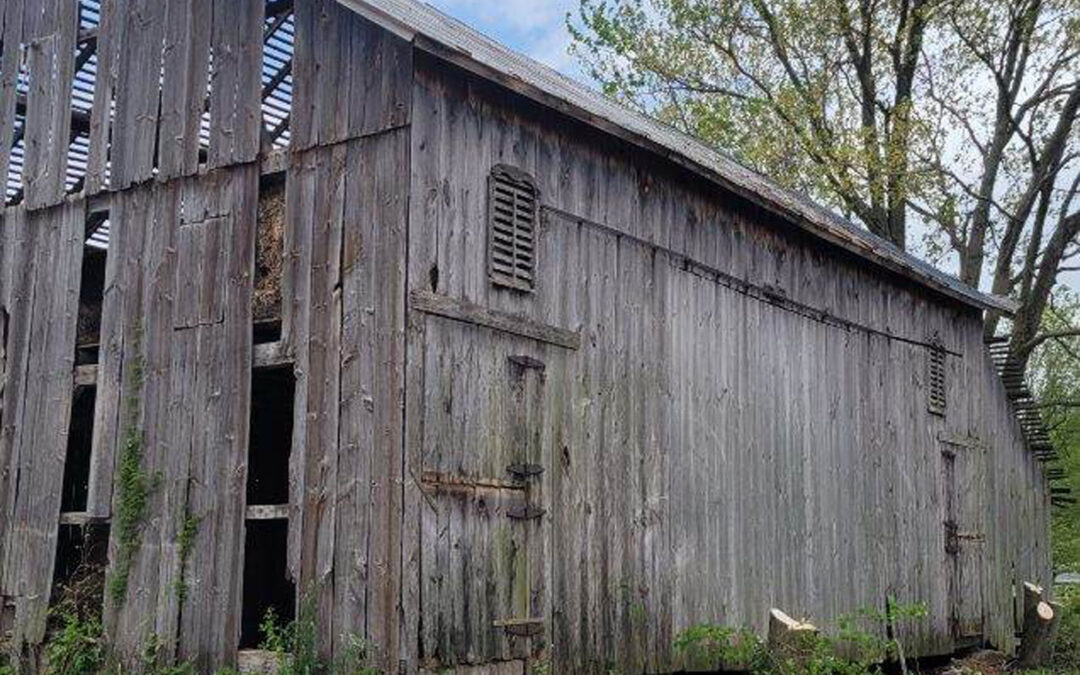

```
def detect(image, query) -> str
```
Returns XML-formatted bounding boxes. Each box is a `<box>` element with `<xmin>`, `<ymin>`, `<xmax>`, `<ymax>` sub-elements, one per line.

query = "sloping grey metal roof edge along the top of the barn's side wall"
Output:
<box><xmin>337</xmin><ymin>0</ymin><xmax>1016</xmax><ymax>313</ymax></box>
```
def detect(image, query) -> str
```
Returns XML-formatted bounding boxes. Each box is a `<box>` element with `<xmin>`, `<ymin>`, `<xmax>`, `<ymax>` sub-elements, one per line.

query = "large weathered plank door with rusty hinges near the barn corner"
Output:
<box><xmin>409</xmin><ymin>295</ymin><xmax>562</xmax><ymax>667</ymax></box>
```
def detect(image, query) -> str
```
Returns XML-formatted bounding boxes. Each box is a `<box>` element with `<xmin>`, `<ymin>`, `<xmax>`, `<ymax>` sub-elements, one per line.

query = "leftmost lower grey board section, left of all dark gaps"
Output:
<box><xmin>0</xmin><ymin>202</ymin><xmax>84</xmax><ymax>645</ymax></box>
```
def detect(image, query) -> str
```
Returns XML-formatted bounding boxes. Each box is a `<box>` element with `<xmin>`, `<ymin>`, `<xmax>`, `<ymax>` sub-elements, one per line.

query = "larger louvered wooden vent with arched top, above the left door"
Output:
<box><xmin>487</xmin><ymin>164</ymin><xmax>538</xmax><ymax>291</ymax></box>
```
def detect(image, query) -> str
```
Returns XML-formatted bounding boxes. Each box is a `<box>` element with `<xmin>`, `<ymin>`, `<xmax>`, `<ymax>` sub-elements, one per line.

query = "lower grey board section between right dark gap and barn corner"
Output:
<box><xmin>282</xmin><ymin>129</ymin><xmax>408</xmax><ymax>670</ymax></box>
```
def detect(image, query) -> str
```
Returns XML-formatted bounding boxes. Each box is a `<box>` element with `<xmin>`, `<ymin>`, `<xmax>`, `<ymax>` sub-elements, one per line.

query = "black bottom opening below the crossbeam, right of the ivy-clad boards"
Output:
<box><xmin>240</xmin><ymin>519</ymin><xmax>296</xmax><ymax>649</ymax></box>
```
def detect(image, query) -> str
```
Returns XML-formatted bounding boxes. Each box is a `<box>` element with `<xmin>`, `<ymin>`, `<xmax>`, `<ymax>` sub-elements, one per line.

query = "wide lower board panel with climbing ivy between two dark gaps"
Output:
<box><xmin>92</xmin><ymin>165</ymin><xmax>258</xmax><ymax>669</ymax></box>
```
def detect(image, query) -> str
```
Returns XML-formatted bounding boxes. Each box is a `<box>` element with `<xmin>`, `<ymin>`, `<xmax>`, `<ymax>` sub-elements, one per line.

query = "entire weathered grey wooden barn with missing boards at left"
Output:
<box><xmin>0</xmin><ymin>0</ymin><xmax>1051</xmax><ymax>675</ymax></box>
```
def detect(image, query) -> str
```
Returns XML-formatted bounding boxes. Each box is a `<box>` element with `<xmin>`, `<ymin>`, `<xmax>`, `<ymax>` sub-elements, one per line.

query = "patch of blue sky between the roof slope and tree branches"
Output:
<box><xmin>427</xmin><ymin>0</ymin><xmax>582</xmax><ymax>80</ymax></box>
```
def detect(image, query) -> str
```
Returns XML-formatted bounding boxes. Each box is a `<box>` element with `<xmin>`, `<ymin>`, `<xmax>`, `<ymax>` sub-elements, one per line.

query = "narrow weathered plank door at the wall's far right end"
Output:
<box><xmin>942</xmin><ymin>436</ymin><xmax>986</xmax><ymax>643</ymax></box>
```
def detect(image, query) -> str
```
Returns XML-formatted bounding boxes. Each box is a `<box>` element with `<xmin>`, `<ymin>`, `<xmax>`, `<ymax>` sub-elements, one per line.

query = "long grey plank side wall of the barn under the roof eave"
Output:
<box><xmin>403</xmin><ymin>57</ymin><xmax>1049</xmax><ymax>672</ymax></box>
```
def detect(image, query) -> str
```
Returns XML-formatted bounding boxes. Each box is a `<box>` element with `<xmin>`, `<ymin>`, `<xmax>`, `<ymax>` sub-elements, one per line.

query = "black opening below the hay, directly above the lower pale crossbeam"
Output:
<box><xmin>247</xmin><ymin>368</ymin><xmax>296</xmax><ymax>505</ymax></box>
